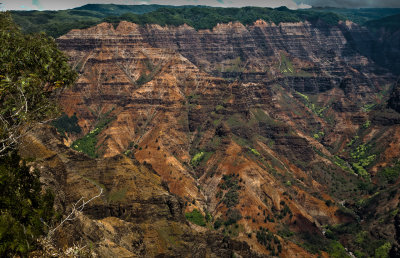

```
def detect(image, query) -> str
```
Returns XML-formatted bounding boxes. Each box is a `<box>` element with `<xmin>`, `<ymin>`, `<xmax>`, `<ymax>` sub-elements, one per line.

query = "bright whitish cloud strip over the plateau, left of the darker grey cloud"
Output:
<box><xmin>3</xmin><ymin>0</ymin><xmax>310</xmax><ymax>10</ymax></box>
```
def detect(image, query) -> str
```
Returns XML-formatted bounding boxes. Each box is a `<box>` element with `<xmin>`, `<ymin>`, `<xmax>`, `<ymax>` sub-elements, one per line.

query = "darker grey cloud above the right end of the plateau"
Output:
<box><xmin>294</xmin><ymin>0</ymin><xmax>400</xmax><ymax>8</ymax></box>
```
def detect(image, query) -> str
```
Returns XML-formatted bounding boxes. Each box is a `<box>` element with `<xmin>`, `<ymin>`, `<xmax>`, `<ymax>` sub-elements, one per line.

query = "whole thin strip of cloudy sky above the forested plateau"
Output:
<box><xmin>0</xmin><ymin>0</ymin><xmax>400</xmax><ymax>10</ymax></box>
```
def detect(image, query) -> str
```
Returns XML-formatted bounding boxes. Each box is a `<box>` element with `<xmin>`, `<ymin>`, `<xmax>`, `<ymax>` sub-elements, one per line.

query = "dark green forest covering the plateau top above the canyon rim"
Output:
<box><xmin>12</xmin><ymin>4</ymin><xmax>400</xmax><ymax>37</ymax></box>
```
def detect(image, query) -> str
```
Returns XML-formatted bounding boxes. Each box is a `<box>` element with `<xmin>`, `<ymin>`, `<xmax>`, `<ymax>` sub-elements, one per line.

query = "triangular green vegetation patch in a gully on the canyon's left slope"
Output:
<box><xmin>71</xmin><ymin>111</ymin><xmax>114</xmax><ymax>158</ymax></box>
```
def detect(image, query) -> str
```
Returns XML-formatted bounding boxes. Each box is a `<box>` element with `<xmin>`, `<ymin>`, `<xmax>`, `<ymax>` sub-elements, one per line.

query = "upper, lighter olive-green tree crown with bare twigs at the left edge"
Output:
<box><xmin>0</xmin><ymin>12</ymin><xmax>77</xmax><ymax>155</ymax></box>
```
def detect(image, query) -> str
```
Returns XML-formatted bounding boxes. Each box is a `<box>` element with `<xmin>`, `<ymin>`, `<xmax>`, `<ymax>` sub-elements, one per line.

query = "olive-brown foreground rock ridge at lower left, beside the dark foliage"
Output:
<box><xmin>21</xmin><ymin>124</ymin><xmax>261</xmax><ymax>257</ymax></box>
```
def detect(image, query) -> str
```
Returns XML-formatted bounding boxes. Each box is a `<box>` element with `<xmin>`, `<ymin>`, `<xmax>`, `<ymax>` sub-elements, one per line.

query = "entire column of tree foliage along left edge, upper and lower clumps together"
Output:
<box><xmin>0</xmin><ymin>12</ymin><xmax>77</xmax><ymax>257</ymax></box>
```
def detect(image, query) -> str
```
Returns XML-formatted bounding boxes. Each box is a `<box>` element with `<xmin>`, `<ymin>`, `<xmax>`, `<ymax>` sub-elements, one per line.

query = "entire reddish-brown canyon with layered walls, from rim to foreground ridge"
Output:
<box><xmin>25</xmin><ymin>17</ymin><xmax>400</xmax><ymax>257</ymax></box>
